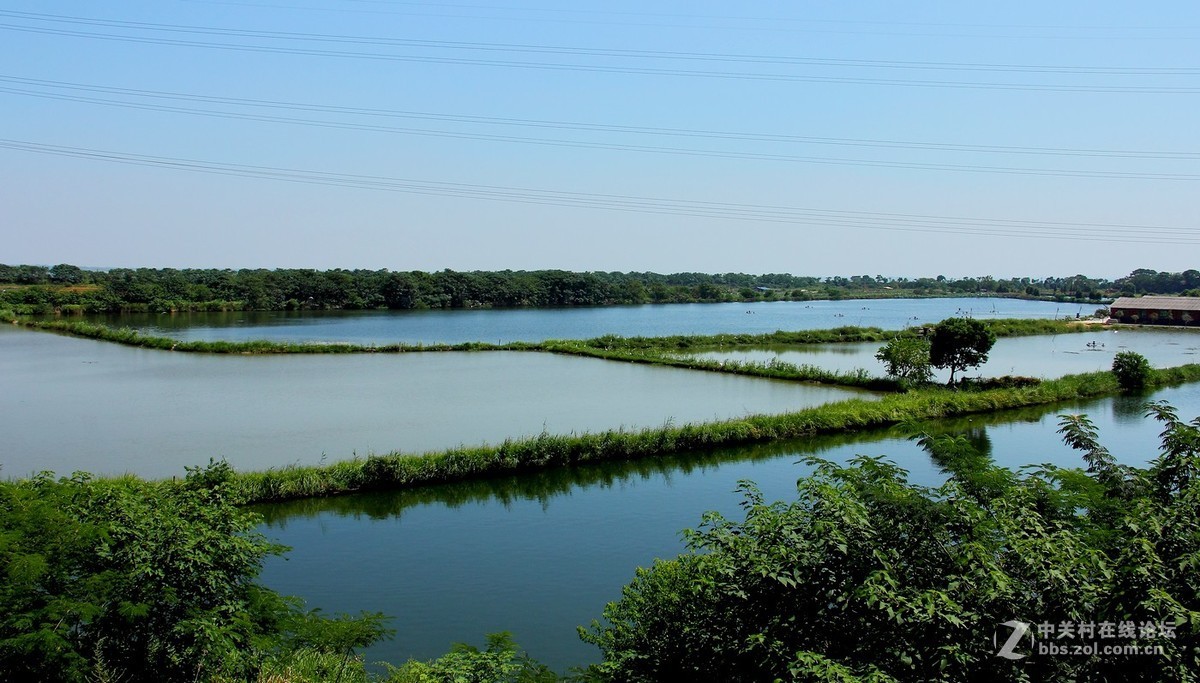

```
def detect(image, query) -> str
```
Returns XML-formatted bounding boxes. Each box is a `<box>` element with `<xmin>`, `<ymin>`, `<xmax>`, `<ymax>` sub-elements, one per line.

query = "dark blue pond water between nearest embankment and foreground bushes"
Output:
<box><xmin>263</xmin><ymin>384</ymin><xmax>1200</xmax><ymax>670</ymax></box>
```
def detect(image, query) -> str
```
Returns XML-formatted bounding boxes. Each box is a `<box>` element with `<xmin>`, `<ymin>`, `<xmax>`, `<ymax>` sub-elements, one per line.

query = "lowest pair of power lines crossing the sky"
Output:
<box><xmin>0</xmin><ymin>139</ymin><xmax>1200</xmax><ymax>245</ymax></box>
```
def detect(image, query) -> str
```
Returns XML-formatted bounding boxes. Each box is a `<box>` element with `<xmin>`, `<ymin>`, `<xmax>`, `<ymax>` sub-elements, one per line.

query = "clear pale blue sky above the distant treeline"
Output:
<box><xmin>0</xmin><ymin>0</ymin><xmax>1200</xmax><ymax>277</ymax></box>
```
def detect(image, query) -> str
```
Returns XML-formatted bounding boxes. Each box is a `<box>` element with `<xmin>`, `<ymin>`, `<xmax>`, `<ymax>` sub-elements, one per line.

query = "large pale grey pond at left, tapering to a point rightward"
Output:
<box><xmin>0</xmin><ymin>325</ymin><xmax>871</xmax><ymax>477</ymax></box>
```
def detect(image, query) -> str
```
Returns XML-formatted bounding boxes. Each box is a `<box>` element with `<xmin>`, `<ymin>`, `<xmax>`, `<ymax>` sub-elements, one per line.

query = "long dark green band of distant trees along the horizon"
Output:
<box><xmin>0</xmin><ymin>264</ymin><xmax>1200</xmax><ymax>314</ymax></box>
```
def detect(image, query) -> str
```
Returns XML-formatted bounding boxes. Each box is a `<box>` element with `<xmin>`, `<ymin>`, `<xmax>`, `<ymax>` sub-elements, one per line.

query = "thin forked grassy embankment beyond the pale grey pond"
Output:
<box><xmin>9</xmin><ymin>319</ymin><xmax>1090</xmax><ymax>391</ymax></box>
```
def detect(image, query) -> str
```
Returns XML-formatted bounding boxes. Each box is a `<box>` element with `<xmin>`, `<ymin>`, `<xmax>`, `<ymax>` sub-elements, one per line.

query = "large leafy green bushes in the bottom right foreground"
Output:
<box><xmin>581</xmin><ymin>405</ymin><xmax>1200</xmax><ymax>683</ymax></box>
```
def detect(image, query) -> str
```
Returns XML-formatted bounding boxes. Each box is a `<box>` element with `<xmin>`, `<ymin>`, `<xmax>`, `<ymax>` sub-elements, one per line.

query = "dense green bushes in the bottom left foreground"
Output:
<box><xmin>0</xmin><ymin>463</ymin><xmax>383</xmax><ymax>682</ymax></box>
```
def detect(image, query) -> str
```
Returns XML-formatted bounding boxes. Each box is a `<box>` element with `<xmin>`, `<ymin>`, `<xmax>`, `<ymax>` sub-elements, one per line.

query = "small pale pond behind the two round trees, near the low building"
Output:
<box><xmin>694</xmin><ymin>328</ymin><xmax>1200</xmax><ymax>381</ymax></box>
